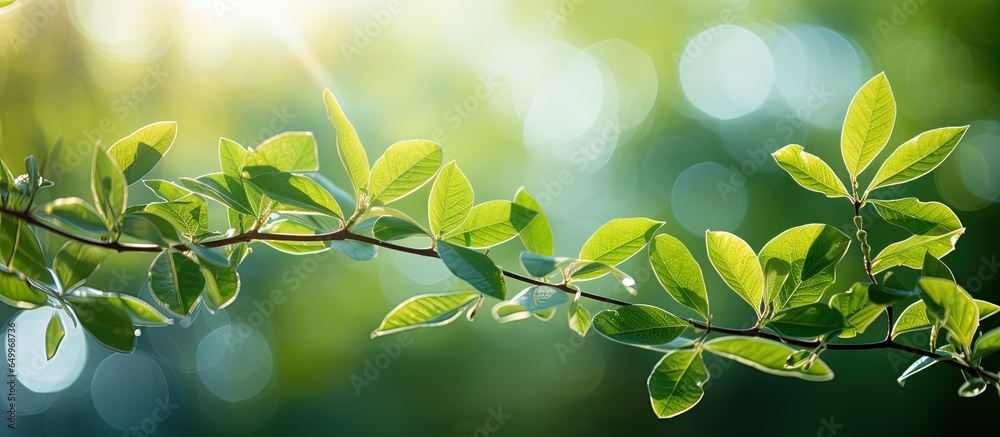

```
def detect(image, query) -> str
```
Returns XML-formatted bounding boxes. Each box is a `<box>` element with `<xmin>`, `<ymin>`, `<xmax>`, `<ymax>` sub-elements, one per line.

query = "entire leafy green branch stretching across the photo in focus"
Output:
<box><xmin>0</xmin><ymin>74</ymin><xmax>1000</xmax><ymax>417</ymax></box>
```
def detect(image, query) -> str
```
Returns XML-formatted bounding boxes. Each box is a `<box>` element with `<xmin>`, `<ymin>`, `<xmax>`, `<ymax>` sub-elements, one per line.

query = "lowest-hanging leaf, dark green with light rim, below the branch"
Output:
<box><xmin>646</xmin><ymin>350</ymin><xmax>708</xmax><ymax>419</ymax></box>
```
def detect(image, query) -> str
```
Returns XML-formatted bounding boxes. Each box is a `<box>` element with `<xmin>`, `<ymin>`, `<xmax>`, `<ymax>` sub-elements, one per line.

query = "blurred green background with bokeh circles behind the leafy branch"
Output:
<box><xmin>0</xmin><ymin>0</ymin><xmax>1000</xmax><ymax>436</ymax></box>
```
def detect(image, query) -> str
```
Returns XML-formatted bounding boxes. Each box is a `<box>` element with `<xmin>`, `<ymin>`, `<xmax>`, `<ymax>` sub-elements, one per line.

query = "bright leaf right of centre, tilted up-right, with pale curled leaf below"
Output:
<box><xmin>580</xmin><ymin>218</ymin><xmax>663</xmax><ymax>277</ymax></box>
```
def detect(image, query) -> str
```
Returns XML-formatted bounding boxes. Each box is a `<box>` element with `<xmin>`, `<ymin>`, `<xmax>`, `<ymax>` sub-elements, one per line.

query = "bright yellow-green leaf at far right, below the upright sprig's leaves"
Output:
<box><xmin>917</xmin><ymin>278</ymin><xmax>979</xmax><ymax>347</ymax></box>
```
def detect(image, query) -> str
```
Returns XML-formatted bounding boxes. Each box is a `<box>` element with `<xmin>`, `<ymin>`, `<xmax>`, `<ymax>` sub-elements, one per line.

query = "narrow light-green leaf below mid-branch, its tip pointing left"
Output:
<box><xmin>372</xmin><ymin>291</ymin><xmax>480</xmax><ymax>338</ymax></box>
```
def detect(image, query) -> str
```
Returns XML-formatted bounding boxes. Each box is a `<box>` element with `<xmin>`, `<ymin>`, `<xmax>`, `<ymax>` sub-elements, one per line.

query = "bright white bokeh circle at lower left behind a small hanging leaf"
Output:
<box><xmin>4</xmin><ymin>307</ymin><xmax>87</xmax><ymax>393</ymax></box>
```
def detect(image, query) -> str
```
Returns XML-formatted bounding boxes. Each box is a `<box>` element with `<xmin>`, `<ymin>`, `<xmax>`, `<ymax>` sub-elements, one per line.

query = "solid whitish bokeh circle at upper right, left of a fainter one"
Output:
<box><xmin>679</xmin><ymin>24</ymin><xmax>774</xmax><ymax>120</ymax></box>
